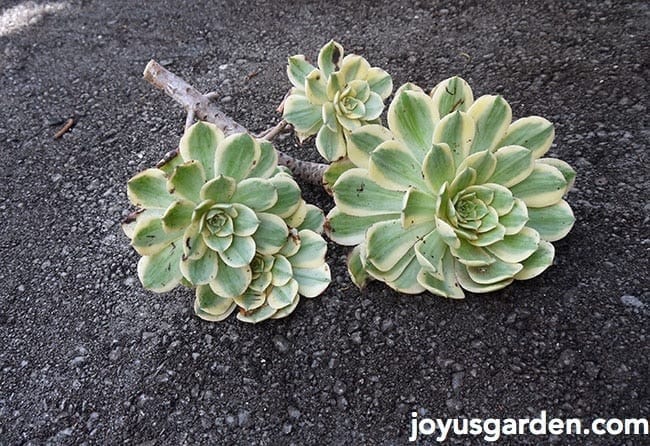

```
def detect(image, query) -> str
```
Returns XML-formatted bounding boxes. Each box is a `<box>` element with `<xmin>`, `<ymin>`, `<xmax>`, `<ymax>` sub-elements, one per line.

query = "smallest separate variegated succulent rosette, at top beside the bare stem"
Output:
<box><xmin>283</xmin><ymin>41</ymin><xmax>393</xmax><ymax>162</ymax></box>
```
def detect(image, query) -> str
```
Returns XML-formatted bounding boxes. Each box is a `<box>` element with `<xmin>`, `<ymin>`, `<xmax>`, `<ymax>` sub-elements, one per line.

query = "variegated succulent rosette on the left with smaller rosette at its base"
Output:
<box><xmin>123</xmin><ymin>122</ymin><xmax>330</xmax><ymax>322</ymax></box>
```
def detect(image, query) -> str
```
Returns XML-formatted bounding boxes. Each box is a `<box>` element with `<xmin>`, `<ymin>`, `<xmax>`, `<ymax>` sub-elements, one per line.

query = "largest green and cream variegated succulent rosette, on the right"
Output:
<box><xmin>326</xmin><ymin>77</ymin><xmax>575</xmax><ymax>298</ymax></box>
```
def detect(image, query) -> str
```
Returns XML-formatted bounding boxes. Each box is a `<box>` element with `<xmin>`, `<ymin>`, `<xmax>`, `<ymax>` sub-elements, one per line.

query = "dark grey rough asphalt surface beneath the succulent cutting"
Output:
<box><xmin>0</xmin><ymin>0</ymin><xmax>650</xmax><ymax>445</ymax></box>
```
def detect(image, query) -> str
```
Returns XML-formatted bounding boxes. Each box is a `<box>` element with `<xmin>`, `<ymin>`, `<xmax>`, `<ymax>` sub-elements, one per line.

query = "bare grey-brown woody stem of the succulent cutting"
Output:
<box><xmin>143</xmin><ymin>60</ymin><xmax>327</xmax><ymax>185</ymax></box>
